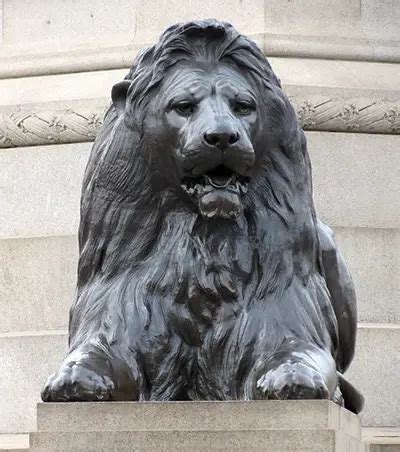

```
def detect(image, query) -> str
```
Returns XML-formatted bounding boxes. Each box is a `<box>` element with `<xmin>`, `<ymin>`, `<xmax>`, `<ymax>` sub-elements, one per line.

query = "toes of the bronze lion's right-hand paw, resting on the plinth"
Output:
<box><xmin>257</xmin><ymin>360</ymin><xmax>329</xmax><ymax>400</ymax></box>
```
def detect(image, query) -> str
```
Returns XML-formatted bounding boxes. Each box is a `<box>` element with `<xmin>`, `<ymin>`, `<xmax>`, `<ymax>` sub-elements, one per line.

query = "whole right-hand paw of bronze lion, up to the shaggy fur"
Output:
<box><xmin>246</xmin><ymin>338</ymin><xmax>341</xmax><ymax>403</ymax></box>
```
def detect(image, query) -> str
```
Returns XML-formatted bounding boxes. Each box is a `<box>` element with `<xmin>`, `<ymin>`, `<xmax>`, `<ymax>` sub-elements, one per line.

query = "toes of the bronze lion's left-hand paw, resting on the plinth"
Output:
<box><xmin>42</xmin><ymin>362</ymin><xmax>115</xmax><ymax>402</ymax></box>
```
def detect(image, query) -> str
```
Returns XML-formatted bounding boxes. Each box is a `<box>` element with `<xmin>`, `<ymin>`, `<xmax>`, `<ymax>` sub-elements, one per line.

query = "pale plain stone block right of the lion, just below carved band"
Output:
<box><xmin>306</xmin><ymin>132</ymin><xmax>400</xmax><ymax>228</ymax></box>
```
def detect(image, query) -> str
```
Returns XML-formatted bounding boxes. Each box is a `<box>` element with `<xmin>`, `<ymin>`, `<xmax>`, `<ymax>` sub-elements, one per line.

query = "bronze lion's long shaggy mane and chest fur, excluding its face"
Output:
<box><xmin>70</xmin><ymin>20</ymin><xmax>342</xmax><ymax>399</ymax></box>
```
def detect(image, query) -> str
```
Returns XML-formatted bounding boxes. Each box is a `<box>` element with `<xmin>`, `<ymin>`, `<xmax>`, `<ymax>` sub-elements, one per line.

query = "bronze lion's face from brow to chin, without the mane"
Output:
<box><xmin>141</xmin><ymin>60</ymin><xmax>260</xmax><ymax>218</ymax></box>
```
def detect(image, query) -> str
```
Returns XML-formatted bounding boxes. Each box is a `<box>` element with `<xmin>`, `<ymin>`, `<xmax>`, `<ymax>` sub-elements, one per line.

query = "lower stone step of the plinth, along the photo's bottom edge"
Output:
<box><xmin>30</xmin><ymin>429</ymin><xmax>356</xmax><ymax>452</ymax></box>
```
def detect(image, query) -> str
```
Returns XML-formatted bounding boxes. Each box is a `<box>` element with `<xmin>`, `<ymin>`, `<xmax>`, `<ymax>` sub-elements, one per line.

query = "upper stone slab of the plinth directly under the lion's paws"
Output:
<box><xmin>37</xmin><ymin>400</ymin><xmax>361</xmax><ymax>438</ymax></box>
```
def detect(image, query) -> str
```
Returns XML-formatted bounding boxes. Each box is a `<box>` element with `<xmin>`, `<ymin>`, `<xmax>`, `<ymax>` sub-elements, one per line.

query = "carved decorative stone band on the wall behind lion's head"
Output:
<box><xmin>0</xmin><ymin>95</ymin><xmax>400</xmax><ymax>148</ymax></box>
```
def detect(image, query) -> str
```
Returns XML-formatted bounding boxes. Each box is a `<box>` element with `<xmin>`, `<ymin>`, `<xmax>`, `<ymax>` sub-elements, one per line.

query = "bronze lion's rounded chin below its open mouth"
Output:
<box><xmin>198</xmin><ymin>189</ymin><xmax>243</xmax><ymax>220</ymax></box>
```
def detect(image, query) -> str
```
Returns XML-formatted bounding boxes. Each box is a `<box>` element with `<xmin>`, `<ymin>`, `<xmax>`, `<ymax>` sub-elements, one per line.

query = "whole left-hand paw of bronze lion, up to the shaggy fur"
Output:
<box><xmin>42</xmin><ymin>338</ymin><xmax>143</xmax><ymax>402</ymax></box>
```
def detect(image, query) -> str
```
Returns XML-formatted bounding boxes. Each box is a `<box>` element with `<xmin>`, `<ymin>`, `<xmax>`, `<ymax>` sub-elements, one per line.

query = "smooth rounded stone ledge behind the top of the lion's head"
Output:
<box><xmin>0</xmin><ymin>33</ymin><xmax>400</xmax><ymax>79</ymax></box>
